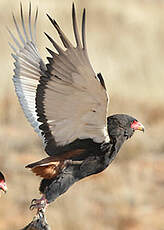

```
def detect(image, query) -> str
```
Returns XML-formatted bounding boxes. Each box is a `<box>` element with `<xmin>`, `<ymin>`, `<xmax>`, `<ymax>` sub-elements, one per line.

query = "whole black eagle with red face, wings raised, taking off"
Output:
<box><xmin>9</xmin><ymin>4</ymin><xmax>144</xmax><ymax>213</ymax></box>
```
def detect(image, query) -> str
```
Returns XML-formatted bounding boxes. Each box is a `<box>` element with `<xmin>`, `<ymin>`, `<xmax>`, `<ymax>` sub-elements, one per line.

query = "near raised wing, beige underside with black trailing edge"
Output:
<box><xmin>36</xmin><ymin>5</ymin><xmax>109</xmax><ymax>155</ymax></box>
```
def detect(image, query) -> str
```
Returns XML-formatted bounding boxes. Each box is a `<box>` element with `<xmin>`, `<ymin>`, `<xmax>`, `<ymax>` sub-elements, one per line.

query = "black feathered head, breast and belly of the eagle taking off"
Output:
<box><xmin>39</xmin><ymin>114</ymin><xmax>142</xmax><ymax>203</ymax></box>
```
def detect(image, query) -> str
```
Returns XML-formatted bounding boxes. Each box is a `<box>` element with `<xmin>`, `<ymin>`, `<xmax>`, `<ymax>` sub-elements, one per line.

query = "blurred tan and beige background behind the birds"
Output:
<box><xmin>0</xmin><ymin>0</ymin><xmax>164</xmax><ymax>230</ymax></box>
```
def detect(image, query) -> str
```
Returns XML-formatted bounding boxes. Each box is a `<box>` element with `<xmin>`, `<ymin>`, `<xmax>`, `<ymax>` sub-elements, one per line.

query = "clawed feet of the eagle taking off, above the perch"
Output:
<box><xmin>30</xmin><ymin>195</ymin><xmax>48</xmax><ymax>213</ymax></box>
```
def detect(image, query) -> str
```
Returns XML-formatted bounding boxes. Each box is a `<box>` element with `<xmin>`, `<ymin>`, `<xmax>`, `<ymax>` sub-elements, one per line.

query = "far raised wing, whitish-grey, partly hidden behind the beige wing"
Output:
<box><xmin>9</xmin><ymin>4</ymin><xmax>46</xmax><ymax>140</ymax></box>
